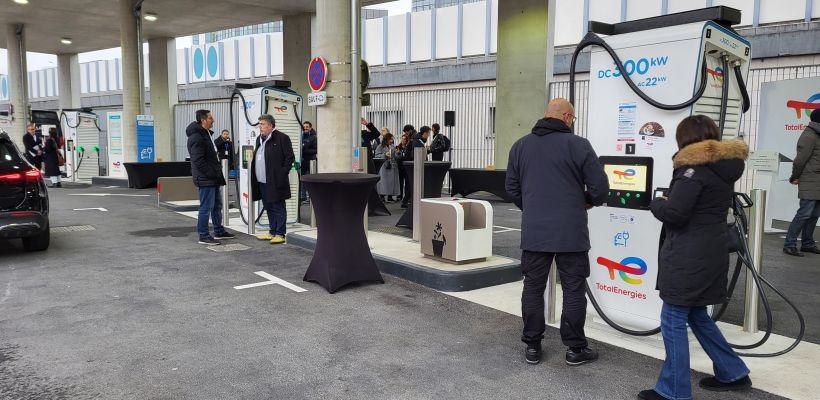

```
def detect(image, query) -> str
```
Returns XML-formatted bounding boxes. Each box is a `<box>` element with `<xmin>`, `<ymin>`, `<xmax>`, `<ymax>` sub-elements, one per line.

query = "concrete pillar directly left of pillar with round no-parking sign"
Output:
<box><xmin>283</xmin><ymin>14</ymin><xmax>319</xmax><ymax>126</ymax></box>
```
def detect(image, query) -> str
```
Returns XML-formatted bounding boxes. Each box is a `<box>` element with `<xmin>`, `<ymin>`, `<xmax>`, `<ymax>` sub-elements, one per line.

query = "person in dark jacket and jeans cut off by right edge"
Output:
<box><xmin>783</xmin><ymin>109</ymin><xmax>820</xmax><ymax>257</ymax></box>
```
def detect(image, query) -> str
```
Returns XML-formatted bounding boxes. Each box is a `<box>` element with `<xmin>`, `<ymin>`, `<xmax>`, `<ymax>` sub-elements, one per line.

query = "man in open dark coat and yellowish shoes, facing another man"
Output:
<box><xmin>251</xmin><ymin>114</ymin><xmax>296</xmax><ymax>244</ymax></box>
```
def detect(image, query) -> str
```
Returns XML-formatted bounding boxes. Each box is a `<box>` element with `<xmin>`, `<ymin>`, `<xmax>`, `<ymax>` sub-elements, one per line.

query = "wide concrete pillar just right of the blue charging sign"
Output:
<box><xmin>148</xmin><ymin>38</ymin><xmax>179</xmax><ymax>162</ymax></box>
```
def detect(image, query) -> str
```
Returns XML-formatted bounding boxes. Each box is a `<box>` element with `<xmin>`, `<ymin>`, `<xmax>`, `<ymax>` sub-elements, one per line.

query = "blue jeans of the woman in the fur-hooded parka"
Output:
<box><xmin>655</xmin><ymin>303</ymin><xmax>749</xmax><ymax>400</ymax></box>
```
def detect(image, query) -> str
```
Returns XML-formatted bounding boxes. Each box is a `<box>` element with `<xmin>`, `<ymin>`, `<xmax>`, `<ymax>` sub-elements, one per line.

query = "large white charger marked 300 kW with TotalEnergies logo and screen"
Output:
<box><xmin>587</xmin><ymin>12</ymin><xmax>751</xmax><ymax>330</ymax></box>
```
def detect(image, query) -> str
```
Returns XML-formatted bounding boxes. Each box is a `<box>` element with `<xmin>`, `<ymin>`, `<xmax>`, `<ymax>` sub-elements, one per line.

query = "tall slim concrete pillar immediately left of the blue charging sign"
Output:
<box><xmin>119</xmin><ymin>0</ymin><xmax>142</xmax><ymax>162</ymax></box>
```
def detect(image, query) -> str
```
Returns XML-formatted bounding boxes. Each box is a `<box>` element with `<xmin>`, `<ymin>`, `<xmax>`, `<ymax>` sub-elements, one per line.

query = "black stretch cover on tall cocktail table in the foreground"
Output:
<box><xmin>302</xmin><ymin>173</ymin><xmax>384</xmax><ymax>293</ymax></box>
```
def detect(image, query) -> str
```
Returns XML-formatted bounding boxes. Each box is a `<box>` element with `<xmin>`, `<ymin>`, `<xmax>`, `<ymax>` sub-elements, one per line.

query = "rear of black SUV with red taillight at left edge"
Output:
<box><xmin>0</xmin><ymin>131</ymin><xmax>50</xmax><ymax>251</ymax></box>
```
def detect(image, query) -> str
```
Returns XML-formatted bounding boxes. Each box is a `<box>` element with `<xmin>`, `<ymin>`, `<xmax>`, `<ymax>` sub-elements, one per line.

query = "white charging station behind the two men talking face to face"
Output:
<box><xmin>231</xmin><ymin>85</ymin><xmax>302</xmax><ymax>228</ymax></box>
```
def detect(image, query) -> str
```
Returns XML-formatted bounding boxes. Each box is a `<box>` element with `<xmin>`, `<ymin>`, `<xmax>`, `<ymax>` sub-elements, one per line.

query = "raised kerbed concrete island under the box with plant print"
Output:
<box><xmin>287</xmin><ymin>229</ymin><xmax>521</xmax><ymax>292</ymax></box>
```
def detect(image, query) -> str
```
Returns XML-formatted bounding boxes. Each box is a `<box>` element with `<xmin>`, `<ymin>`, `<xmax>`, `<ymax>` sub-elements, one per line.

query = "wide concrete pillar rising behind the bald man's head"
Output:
<box><xmin>495</xmin><ymin>0</ymin><xmax>552</xmax><ymax>169</ymax></box>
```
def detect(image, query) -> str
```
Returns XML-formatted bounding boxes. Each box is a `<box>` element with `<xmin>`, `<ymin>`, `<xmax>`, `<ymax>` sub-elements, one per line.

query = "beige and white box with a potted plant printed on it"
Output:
<box><xmin>421</xmin><ymin>197</ymin><xmax>493</xmax><ymax>264</ymax></box>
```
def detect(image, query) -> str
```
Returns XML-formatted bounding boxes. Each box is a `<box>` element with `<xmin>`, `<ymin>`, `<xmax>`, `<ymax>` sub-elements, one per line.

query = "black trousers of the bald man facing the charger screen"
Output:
<box><xmin>521</xmin><ymin>250</ymin><xmax>589</xmax><ymax>349</ymax></box>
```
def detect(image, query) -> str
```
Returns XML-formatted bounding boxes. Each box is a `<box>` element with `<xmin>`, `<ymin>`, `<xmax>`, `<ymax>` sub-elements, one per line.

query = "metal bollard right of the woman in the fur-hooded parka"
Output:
<box><xmin>743</xmin><ymin>189</ymin><xmax>766</xmax><ymax>333</ymax></box>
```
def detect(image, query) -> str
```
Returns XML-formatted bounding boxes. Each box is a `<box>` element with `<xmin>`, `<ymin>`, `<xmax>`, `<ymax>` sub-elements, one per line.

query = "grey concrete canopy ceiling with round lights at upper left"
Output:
<box><xmin>0</xmin><ymin>0</ymin><xmax>388</xmax><ymax>54</ymax></box>
